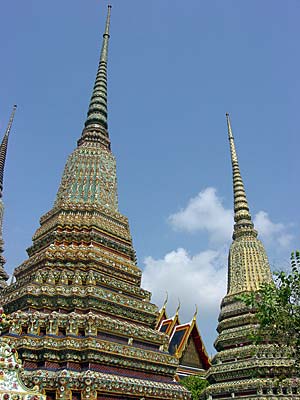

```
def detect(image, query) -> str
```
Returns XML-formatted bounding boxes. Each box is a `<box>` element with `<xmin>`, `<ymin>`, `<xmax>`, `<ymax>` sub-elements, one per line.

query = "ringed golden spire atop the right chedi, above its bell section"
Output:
<box><xmin>226</xmin><ymin>113</ymin><xmax>257</xmax><ymax>239</ymax></box>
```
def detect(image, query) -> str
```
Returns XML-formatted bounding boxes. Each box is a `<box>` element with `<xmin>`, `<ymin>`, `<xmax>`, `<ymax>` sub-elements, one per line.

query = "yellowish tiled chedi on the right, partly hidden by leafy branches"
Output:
<box><xmin>203</xmin><ymin>114</ymin><xmax>300</xmax><ymax>400</ymax></box>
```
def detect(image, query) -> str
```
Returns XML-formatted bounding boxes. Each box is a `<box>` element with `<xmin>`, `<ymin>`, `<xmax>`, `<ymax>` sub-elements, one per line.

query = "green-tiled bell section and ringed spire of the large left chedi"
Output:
<box><xmin>56</xmin><ymin>6</ymin><xmax>118</xmax><ymax>211</ymax></box>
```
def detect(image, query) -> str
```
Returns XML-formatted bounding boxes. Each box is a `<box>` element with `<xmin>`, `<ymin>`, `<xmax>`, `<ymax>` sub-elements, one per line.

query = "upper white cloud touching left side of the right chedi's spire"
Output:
<box><xmin>169</xmin><ymin>187</ymin><xmax>233</xmax><ymax>244</ymax></box>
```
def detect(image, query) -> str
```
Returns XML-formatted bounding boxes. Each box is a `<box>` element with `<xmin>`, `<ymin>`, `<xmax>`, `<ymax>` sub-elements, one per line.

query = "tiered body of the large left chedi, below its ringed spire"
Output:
<box><xmin>2</xmin><ymin>144</ymin><xmax>190</xmax><ymax>400</ymax></box>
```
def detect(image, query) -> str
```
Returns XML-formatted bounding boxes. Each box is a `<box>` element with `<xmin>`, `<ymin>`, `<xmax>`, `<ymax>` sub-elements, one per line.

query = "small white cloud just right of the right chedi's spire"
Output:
<box><xmin>254</xmin><ymin>211</ymin><xmax>294</xmax><ymax>248</ymax></box>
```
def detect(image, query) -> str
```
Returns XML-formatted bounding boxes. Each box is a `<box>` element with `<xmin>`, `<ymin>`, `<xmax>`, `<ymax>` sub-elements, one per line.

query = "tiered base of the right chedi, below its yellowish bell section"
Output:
<box><xmin>203</xmin><ymin>295</ymin><xmax>300</xmax><ymax>399</ymax></box>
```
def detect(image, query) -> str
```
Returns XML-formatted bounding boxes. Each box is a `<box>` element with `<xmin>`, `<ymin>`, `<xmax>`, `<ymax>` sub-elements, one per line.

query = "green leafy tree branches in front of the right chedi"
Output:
<box><xmin>242</xmin><ymin>251</ymin><xmax>300</xmax><ymax>369</ymax></box>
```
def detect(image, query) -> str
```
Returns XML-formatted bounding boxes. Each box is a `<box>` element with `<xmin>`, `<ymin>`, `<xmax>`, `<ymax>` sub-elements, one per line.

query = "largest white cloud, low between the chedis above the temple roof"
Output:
<box><xmin>142</xmin><ymin>248</ymin><xmax>227</xmax><ymax>352</ymax></box>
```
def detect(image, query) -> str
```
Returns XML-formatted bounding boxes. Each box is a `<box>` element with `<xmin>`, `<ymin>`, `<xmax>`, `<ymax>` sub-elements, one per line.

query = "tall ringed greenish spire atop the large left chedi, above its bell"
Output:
<box><xmin>78</xmin><ymin>5</ymin><xmax>111</xmax><ymax>147</ymax></box>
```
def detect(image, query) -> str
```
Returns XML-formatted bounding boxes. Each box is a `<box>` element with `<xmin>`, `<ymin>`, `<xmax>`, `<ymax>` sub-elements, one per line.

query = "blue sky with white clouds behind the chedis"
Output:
<box><xmin>0</xmin><ymin>0</ymin><xmax>300</xmax><ymax>352</ymax></box>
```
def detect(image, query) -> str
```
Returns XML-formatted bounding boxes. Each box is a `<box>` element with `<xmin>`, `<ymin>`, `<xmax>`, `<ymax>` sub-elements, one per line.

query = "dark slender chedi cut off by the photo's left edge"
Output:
<box><xmin>0</xmin><ymin>105</ymin><xmax>17</xmax><ymax>289</ymax></box>
